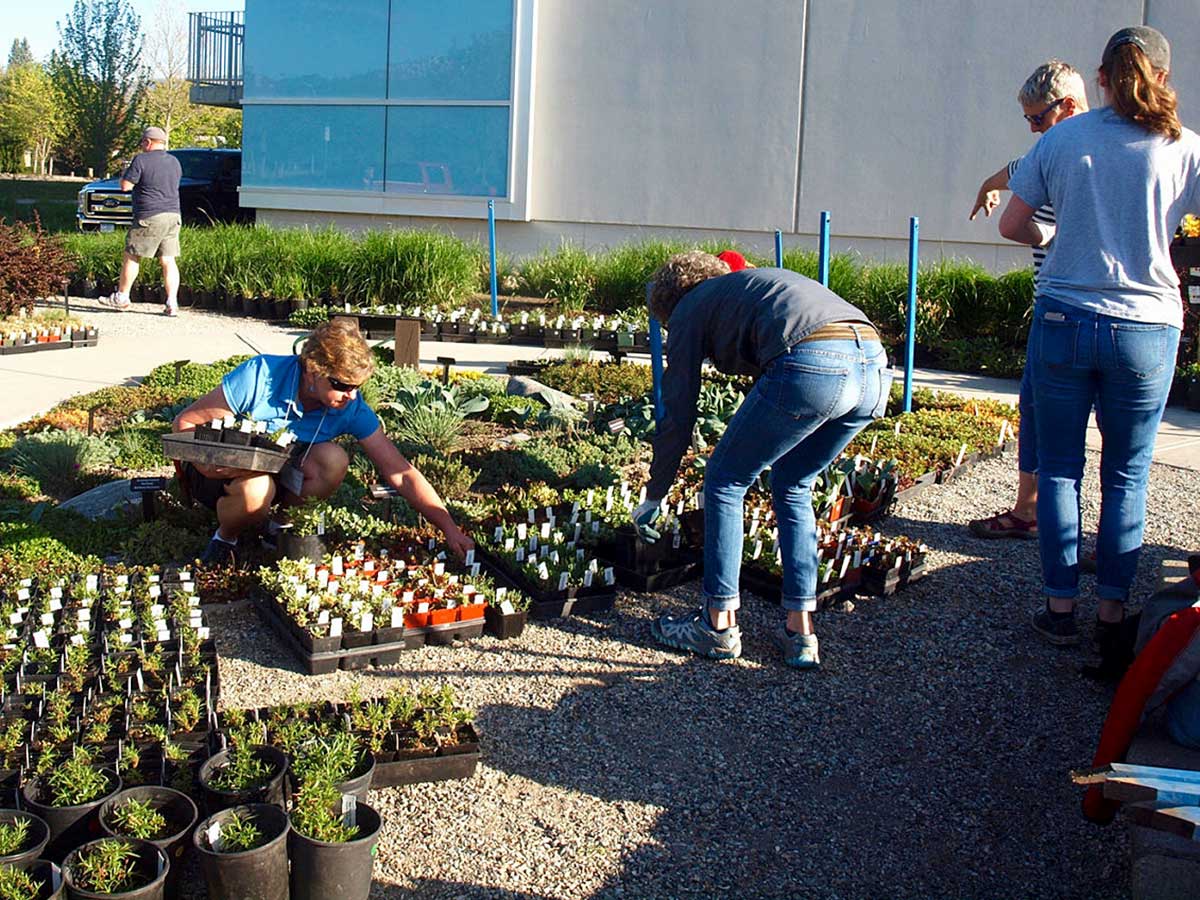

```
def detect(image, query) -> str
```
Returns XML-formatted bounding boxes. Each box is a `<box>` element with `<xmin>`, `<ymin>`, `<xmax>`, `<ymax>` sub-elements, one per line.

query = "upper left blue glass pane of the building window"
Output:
<box><xmin>245</xmin><ymin>0</ymin><xmax>388</xmax><ymax>100</ymax></box>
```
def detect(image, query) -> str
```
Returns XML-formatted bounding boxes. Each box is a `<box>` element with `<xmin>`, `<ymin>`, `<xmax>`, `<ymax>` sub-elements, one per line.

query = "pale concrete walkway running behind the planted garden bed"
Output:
<box><xmin>7</xmin><ymin>298</ymin><xmax>1200</xmax><ymax>470</ymax></box>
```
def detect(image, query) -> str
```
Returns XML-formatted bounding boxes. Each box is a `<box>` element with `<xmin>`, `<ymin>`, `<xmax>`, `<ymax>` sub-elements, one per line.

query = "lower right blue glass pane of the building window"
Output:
<box><xmin>384</xmin><ymin>107</ymin><xmax>509</xmax><ymax>197</ymax></box>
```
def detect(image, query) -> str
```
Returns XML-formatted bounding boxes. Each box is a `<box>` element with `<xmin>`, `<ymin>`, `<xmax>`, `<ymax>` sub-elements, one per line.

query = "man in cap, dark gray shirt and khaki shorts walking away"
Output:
<box><xmin>102</xmin><ymin>126</ymin><xmax>182</xmax><ymax>316</ymax></box>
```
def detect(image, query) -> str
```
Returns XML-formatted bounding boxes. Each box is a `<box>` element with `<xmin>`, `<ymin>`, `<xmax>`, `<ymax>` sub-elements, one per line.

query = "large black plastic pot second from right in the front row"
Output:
<box><xmin>192</xmin><ymin>803</ymin><xmax>292</xmax><ymax>900</ymax></box>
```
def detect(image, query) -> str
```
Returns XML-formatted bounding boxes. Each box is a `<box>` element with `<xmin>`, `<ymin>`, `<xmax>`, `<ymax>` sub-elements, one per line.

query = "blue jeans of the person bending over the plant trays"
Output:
<box><xmin>703</xmin><ymin>338</ymin><xmax>892</xmax><ymax>611</ymax></box>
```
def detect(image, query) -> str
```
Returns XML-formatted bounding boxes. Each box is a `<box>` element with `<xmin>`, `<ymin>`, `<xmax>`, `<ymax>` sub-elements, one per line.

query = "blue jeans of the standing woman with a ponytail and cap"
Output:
<box><xmin>1027</xmin><ymin>298</ymin><xmax>1180</xmax><ymax>602</ymax></box>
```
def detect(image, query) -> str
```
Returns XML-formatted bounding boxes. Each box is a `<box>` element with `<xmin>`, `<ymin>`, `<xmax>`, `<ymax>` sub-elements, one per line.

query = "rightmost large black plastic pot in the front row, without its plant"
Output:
<box><xmin>288</xmin><ymin>803</ymin><xmax>382</xmax><ymax>900</ymax></box>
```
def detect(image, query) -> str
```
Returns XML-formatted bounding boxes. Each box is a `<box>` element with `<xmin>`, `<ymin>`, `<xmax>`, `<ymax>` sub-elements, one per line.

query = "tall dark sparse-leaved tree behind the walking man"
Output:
<box><xmin>50</xmin><ymin>0</ymin><xmax>146</xmax><ymax>174</ymax></box>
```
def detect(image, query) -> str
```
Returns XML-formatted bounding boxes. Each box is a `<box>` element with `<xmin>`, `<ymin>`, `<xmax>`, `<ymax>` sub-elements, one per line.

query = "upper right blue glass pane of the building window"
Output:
<box><xmin>388</xmin><ymin>0</ymin><xmax>512</xmax><ymax>100</ymax></box>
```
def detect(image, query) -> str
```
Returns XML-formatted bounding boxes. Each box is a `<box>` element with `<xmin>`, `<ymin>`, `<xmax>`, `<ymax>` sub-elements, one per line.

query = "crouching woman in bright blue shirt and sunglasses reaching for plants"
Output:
<box><xmin>174</xmin><ymin>319</ymin><xmax>474</xmax><ymax>562</ymax></box>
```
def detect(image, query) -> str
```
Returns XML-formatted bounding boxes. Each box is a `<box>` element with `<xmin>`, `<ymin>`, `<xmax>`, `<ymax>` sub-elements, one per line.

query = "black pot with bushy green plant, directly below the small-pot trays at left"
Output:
<box><xmin>20</xmin><ymin>756</ymin><xmax>121</xmax><ymax>863</ymax></box>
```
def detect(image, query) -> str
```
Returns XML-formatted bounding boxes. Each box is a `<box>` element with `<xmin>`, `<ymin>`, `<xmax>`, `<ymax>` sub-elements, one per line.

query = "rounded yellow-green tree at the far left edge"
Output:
<box><xmin>0</xmin><ymin>62</ymin><xmax>62</xmax><ymax>175</ymax></box>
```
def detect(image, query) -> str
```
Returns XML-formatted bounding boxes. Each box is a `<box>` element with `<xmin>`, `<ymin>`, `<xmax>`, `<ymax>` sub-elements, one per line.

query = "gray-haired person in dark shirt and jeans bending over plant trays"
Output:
<box><xmin>634</xmin><ymin>252</ymin><xmax>892</xmax><ymax>668</ymax></box>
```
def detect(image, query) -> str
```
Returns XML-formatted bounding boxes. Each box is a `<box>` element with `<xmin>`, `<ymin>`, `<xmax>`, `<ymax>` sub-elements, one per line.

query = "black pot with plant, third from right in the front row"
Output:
<box><xmin>62</xmin><ymin>838</ymin><xmax>170</xmax><ymax>900</ymax></box>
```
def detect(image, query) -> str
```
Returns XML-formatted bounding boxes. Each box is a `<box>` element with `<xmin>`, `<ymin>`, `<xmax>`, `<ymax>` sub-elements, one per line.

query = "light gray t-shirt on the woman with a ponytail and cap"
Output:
<box><xmin>1008</xmin><ymin>107</ymin><xmax>1200</xmax><ymax>328</ymax></box>
